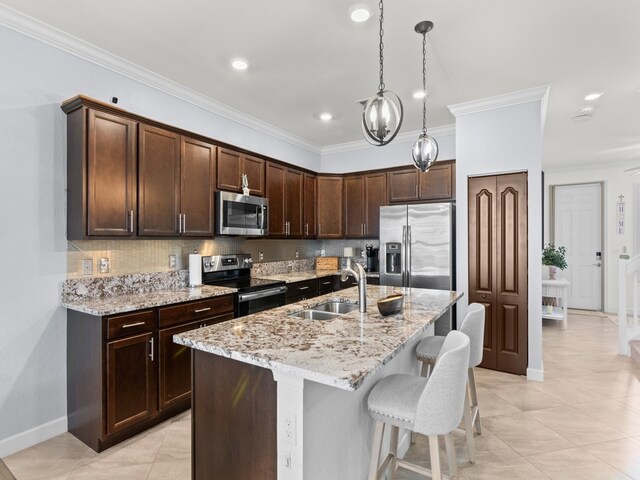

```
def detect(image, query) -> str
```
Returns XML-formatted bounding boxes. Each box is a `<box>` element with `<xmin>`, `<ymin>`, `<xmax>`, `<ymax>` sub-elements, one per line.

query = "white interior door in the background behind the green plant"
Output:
<box><xmin>553</xmin><ymin>183</ymin><xmax>603</xmax><ymax>310</ymax></box>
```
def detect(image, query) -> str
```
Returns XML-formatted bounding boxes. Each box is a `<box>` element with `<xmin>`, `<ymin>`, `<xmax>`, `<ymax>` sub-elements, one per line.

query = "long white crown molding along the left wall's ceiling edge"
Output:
<box><xmin>0</xmin><ymin>4</ymin><xmax>321</xmax><ymax>155</ymax></box>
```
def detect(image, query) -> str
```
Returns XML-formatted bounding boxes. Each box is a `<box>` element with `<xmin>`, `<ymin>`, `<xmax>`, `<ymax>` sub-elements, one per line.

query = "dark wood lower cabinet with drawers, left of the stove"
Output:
<box><xmin>67</xmin><ymin>295</ymin><xmax>233</xmax><ymax>452</ymax></box>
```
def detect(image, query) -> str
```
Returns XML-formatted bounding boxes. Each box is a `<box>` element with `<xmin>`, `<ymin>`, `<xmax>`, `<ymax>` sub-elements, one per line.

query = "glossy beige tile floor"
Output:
<box><xmin>3</xmin><ymin>312</ymin><xmax>640</xmax><ymax>480</ymax></box>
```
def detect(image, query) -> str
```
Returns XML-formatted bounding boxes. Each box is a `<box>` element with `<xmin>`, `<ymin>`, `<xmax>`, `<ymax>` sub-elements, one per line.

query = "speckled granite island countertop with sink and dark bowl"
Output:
<box><xmin>173</xmin><ymin>286</ymin><xmax>462</xmax><ymax>390</ymax></box>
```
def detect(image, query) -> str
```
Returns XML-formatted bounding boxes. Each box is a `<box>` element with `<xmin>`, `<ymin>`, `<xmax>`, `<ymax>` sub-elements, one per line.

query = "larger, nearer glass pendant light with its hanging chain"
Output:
<box><xmin>362</xmin><ymin>0</ymin><xmax>403</xmax><ymax>147</ymax></box>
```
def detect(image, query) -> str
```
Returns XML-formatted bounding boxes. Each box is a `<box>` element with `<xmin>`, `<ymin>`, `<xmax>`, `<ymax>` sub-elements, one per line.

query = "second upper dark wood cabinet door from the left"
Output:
<box><xmin>138</xmin><ymin>124</ymin><xmax>180</xmax><ymax>236</ymax></box>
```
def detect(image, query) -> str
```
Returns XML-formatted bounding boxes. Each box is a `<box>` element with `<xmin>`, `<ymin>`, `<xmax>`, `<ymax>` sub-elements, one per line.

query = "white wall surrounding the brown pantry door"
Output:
<box><xmin>452</xmin><ymin>91</ymin><xmax>543</xmax><ymax>380</ymax></box>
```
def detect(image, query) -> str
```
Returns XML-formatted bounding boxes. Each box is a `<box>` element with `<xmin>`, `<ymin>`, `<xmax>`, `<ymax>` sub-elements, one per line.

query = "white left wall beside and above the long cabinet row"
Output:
<box><xmin>0</xmin><ymin>23</ymin><xmax>320</xmax><ymax>456</ymax></box>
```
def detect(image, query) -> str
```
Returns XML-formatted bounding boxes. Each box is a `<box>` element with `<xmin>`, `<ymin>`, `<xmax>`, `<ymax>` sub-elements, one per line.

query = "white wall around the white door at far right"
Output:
<box><xmin>544</xmin><ymin>163</ymin><xmax>640</xmax><ymax>313</ymax></box>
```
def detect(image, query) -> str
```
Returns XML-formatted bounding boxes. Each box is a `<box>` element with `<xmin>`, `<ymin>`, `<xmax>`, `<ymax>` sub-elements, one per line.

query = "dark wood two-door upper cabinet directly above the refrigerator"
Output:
<box><xmin>387</xmin><ymin>160</ymin><xmax>456</xmax><ymax>203</ymax></box>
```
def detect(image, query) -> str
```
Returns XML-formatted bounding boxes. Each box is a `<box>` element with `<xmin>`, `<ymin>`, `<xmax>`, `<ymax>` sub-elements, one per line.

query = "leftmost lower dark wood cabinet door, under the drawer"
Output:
<box><xmin>105</xmin><ymin>333</ymin><xmax>156</xmax><ymax>435</ymax></box>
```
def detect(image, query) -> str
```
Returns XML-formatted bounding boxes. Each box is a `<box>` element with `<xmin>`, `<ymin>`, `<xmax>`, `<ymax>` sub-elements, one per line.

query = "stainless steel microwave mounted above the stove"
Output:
<box><xmin>216</xmin><ymin>191</ymin><xmax>269</xmax><ymax>237</ymax></box>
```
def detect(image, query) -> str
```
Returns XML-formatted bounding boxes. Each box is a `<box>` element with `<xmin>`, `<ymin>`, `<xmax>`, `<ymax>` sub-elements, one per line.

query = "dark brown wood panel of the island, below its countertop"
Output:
<box><xmin>191</xmin><ymin>350</ymin><xmax>278</xmax><ymax>480</ymax></box>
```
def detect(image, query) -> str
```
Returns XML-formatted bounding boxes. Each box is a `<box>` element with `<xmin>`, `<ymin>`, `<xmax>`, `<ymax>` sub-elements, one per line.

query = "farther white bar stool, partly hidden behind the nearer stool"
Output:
<box><xmin>411</xmin><ymin>303</ymin><xmax>485</xmax><ymax>463</ymax></box>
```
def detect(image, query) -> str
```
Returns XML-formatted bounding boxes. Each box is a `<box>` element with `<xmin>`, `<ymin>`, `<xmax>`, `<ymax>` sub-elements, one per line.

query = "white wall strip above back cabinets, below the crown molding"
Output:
<box><xmin>320</xmin><ymin>127</ymin><xmax>456</xmax><ymax>173</ymax></box>
